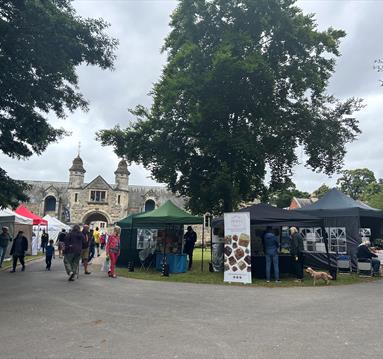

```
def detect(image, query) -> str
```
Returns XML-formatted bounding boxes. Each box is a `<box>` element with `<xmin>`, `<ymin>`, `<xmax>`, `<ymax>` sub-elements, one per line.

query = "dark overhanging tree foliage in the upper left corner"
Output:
<box><xmin>0</xmin><ymin>0</ymin><xmax>117</xmax><ymax>207</ymax></box>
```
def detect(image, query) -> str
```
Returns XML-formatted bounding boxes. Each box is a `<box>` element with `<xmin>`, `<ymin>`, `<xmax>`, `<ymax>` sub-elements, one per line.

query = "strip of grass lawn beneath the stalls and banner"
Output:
<box><xmin>117</xmin><ymin>248</ymin><xmax>380</xmax><ymax>288</ymax></box>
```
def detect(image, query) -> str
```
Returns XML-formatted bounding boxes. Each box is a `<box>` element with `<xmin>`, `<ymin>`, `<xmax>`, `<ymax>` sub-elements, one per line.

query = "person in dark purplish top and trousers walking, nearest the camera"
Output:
<box><xmin>64</xmin><ymin>224</ymin><xmax>84</xmax><ymax>281</ymax></box>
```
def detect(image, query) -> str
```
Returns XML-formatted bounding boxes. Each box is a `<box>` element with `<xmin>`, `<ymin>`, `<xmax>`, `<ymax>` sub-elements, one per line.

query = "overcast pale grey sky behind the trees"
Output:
<box><xmin>0</xmin><ymin>0</ymin><xmax>383</xmax><ymax>192</ymax></box>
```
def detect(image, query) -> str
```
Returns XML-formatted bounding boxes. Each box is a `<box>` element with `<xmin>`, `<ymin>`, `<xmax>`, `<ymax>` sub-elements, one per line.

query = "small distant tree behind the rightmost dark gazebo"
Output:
<box><xmin>336</xmin><ymin>168</ymin><xmax>377</xmax><ymax>200</ymax></box>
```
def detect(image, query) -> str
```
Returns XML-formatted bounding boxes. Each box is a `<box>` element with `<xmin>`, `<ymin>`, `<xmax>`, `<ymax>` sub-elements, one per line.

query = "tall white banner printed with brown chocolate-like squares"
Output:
<box><xmin>223</xmin><ymin>212</ymin><xmax>251</xmax><ymax>283</ymax></box>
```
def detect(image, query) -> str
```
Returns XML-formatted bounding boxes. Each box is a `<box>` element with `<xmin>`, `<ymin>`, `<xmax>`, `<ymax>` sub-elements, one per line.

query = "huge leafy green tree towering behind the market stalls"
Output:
<box><xmin>99</xmin><ymin>0</ymin><xmax>361</xmax><ymax>213</ymax></box>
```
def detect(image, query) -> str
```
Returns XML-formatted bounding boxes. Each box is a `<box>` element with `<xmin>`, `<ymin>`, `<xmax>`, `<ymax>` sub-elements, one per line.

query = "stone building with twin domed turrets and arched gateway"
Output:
<box><xmin>25</xmin><ymin>156</ymin><xmax>184</xmax><ymax>228</ymax></box>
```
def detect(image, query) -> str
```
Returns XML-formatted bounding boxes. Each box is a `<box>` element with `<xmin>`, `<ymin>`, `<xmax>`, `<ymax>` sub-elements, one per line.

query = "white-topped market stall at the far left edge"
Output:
<box><xmin>0</xmin><ymin>208</ymin><xmax>33</xmax><ymax>256</ymax></box>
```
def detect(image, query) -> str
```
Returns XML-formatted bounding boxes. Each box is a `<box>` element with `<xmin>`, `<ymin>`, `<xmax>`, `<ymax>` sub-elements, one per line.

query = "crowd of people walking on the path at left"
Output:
<box><xmin>0</xmin><ymin>224</ymin><xmax>120</xmax><ymax>281</ymax></box>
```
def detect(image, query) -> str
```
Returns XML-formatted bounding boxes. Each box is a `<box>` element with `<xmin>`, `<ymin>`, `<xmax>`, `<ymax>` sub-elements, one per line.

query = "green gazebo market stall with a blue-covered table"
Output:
<box><xmin>117</xmin><ymin>200</ymin><xmax>203</xmax><ymax>273</ymax></box>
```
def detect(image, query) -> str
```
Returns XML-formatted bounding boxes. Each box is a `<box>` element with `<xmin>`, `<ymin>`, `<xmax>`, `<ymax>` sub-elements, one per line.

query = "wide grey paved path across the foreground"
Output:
<box><xmin>0</xmin><ymin>259</ymin><xmax>383</xmax><ymax>359</ymax></box>
